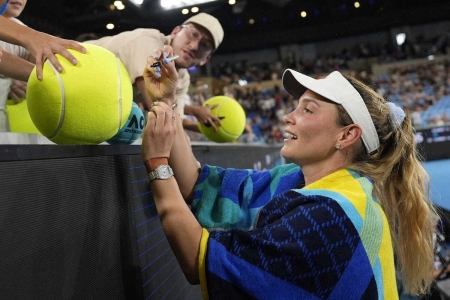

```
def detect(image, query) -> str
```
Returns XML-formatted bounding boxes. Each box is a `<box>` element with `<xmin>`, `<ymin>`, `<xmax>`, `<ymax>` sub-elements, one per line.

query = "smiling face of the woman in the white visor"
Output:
<box><xmin>281</xmin><ymin>90</ymin><xmax>343</xmax><ymax>167</ymax></box>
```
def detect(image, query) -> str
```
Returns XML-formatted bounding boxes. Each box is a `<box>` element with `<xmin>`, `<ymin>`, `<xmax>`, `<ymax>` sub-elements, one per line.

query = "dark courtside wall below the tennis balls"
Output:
<box><xmin>0</xmin><ymin>145</ymin><xmax>282</xmax><ymax>300</ymax></box>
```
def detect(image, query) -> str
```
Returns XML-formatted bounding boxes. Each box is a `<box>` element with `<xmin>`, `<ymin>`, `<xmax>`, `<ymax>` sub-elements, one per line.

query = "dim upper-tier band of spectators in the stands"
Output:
<box><xmin>212</xmin><ymin>30</ymin><xmax>450</xmax><ymax>84</ymax></box>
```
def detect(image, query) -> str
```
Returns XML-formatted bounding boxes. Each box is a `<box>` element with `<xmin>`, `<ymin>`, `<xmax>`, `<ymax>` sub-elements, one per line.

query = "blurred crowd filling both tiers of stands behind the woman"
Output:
<box><xmin>191</xmin><ymin>32</ymin><xmax>450</xmax><ymax>144</ymax></box>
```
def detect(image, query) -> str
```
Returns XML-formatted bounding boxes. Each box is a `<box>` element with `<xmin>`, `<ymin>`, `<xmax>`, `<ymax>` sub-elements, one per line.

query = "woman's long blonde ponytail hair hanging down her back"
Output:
<box><xmin>338</xmin><ymin>76</ymin><xmax>435</xmax><ymax>295</ymax></box>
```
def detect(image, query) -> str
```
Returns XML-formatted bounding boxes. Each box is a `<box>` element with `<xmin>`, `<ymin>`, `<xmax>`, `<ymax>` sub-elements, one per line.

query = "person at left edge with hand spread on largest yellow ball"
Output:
<box><xmin>0</xmin><ymin>0</ymin><xmax>86</xmax><ymax>132</ymax></box>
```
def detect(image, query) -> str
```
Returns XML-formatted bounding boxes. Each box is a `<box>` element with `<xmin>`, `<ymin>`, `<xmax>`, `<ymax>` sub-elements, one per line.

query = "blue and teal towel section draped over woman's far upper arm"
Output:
<box><xmin>191</xmin><ymin>164</ymin><xmax>303</xmax><ymax>230</ymax></box>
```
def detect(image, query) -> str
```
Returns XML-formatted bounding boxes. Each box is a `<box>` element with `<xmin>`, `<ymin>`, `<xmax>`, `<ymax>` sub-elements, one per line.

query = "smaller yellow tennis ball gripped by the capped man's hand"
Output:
<box><xmin>198</xmin><ymin>96</ymin><xmax>246</xmax><ymax>143</ymax></box>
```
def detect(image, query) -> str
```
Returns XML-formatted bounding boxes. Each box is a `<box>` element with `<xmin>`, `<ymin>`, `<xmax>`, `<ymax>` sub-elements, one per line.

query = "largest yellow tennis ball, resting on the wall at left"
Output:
<box><xmin>27</xmin><ymin>44</ymin><xmax>133</xmax><ymax>144</ymax></box>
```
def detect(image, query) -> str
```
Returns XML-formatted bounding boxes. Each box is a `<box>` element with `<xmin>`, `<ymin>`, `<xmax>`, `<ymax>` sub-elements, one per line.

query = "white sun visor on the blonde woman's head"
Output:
<box><xmin>283</xmin><ymin>69</ymin><xmax>380</xmax><ymax>155</ymax></box>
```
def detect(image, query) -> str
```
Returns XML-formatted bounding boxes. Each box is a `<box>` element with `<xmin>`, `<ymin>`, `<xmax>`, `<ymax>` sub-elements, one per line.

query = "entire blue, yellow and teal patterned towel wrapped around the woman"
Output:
<box><xmin>192</xmin><ymin>164</ymin><xmax>398</xmax><ymax>299</ymax></box>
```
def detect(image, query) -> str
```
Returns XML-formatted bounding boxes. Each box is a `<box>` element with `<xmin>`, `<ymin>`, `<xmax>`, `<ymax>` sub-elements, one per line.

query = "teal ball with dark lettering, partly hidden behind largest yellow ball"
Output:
<box><xmin>106</xmin><ymin>102</ymin><xmax>145</xmax><ymax>145</ymax></box>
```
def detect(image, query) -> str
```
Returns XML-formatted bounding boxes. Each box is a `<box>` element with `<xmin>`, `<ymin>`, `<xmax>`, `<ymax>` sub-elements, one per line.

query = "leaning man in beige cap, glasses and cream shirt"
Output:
<box><xmin>86</xmin><ymin>13</ymin><xmax>224</xmax><ymax>132</ymax></box>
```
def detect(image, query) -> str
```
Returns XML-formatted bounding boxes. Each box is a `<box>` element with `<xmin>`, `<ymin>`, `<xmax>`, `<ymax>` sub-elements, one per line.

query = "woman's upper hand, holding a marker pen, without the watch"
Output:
<box><xmin>144</xmin><ymin>45</ymin><xmax>178</xmax><ymax>106</ymax></box>
